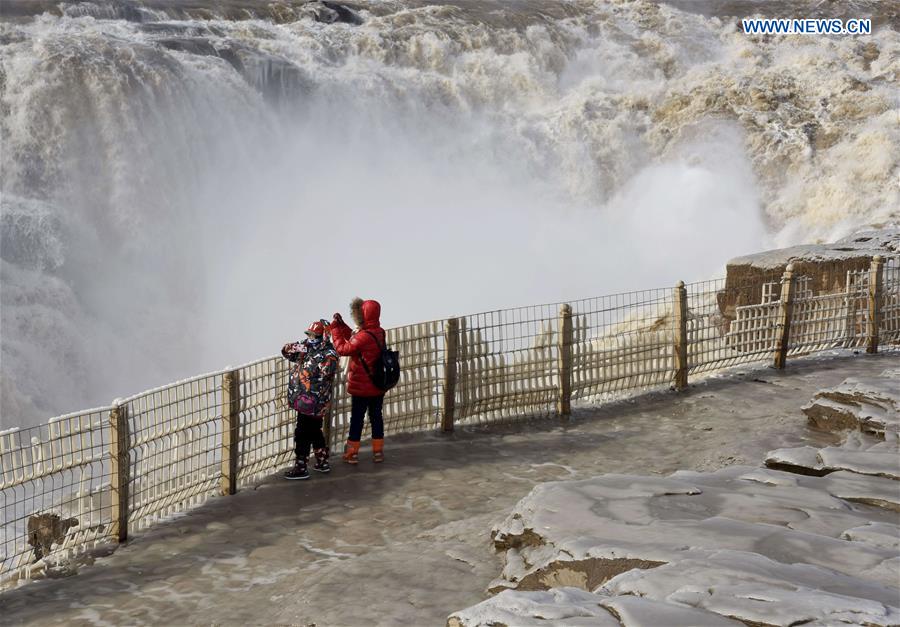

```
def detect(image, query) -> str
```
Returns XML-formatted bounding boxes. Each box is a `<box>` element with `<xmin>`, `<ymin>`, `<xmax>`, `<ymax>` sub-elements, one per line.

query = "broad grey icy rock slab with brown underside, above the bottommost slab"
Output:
<box><xmin>493</xmin><ymin>466</ymin><xmax>900</xmax><ymax>591</ymax></box>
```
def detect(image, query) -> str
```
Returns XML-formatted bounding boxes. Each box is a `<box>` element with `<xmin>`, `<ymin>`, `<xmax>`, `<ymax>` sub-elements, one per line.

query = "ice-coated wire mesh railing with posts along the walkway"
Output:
<box><xmin>0</xmin><ymin>258</ymin><xmax>900</xmax><ymax>582</ymax></box>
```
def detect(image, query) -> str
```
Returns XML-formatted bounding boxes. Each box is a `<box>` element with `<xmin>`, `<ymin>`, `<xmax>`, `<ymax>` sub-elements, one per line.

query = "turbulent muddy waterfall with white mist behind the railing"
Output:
<box><xmin>0</xmin><ymin>0</ymin><xmax>900</xmax><ymax>427</ymax></box>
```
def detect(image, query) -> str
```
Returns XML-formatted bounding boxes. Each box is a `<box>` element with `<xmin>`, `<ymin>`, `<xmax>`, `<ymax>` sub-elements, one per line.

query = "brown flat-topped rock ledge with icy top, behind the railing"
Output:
<box><xmin>718</xmin><ymin>229</ymin><xmax>900</xmax><ymax>321</ymax></box>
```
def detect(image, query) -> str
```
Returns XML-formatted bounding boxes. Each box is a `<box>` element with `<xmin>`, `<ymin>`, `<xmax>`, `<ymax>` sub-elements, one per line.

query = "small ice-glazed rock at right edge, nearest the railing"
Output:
<box><xmin>803</xmin><ymin>370</ymin><xmax>900</xmax><ymax>436</ymax></box>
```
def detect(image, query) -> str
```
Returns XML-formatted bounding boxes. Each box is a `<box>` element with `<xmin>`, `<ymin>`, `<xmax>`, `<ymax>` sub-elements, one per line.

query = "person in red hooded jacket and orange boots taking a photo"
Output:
<box><xmin>329</xmin><ymin>298</ymin><xmax>386</xmax><ymax>464</ymax></box>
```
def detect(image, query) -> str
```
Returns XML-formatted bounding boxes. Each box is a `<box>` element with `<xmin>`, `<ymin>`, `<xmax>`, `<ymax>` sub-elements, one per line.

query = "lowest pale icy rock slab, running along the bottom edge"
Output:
<box><xmin>448</xmin><ymin>551</ymin><xmax>900</xmax><ymax>627</ymax></box>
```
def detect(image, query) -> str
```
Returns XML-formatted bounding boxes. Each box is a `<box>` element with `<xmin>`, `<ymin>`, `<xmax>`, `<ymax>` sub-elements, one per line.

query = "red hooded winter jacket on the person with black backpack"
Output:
<box><xmin>330</xmin><ymin>300</ymin><xmax>386</xmax><ymax>397</ymax></box>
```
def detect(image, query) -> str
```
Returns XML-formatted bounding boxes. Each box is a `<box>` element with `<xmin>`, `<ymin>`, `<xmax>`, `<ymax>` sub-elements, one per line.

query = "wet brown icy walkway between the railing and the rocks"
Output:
<box><xmin>0</xmin><ymin>353</ymin><xmax>900</xmax><ymax>627</ymax></box>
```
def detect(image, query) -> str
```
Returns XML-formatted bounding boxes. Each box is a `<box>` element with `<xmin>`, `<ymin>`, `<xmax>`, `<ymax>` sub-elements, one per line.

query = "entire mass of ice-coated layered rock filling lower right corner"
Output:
<box><xmin>448</xmin><ymin>370</ymin><xmax>900</xmax><ymax>627</ymax></box>
